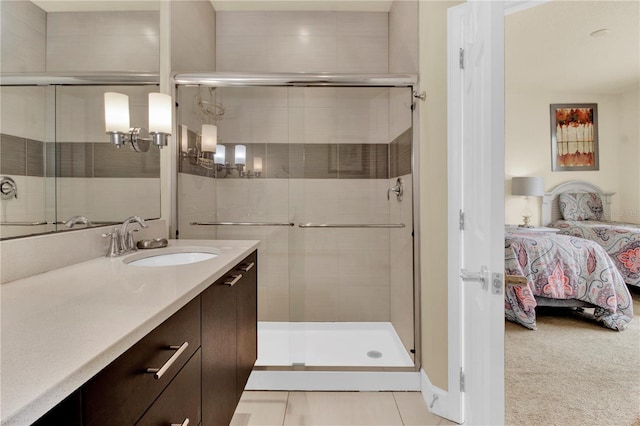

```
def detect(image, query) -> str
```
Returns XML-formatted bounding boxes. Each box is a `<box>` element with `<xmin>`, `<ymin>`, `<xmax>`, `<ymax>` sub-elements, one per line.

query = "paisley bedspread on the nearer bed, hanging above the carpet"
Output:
<box><xmin>504</xmin><ymin>231</ymin><xmax>633</xmax><ymax>330</ymax></box>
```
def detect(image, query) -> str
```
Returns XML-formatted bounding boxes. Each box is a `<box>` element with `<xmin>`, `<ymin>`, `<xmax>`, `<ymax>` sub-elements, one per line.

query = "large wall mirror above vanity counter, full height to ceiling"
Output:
<box><xmin>0</xmin><ymin>0</ymin><xmax>160</xmax><ymax>239</ymax></box>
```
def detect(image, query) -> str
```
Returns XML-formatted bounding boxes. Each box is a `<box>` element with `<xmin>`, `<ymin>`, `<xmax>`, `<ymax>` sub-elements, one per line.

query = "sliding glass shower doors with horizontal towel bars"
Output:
<box><xmin>179</xmin><ymin>83</ymin><xmax>414</xmax><ymax>369</ymax></box>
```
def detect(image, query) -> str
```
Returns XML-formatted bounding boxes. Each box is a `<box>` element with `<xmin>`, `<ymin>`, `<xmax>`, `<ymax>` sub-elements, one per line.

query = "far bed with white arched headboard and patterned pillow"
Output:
<box><xmin>542</xmin><ymin>181</ymin><xmax>640</xmax><ymax>287</ymax></box>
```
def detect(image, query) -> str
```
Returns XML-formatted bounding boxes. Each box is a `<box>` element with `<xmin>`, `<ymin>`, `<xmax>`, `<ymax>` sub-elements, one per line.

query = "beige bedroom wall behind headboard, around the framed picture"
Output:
<box><xmin>505</xmin><ymin>90</ymin><xmax>640</xmax><ymax>225</ymax></box>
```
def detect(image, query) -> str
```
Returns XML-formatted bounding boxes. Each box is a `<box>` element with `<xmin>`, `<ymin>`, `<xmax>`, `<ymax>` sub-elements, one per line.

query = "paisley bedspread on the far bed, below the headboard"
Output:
<box><xmin>550</xmin><ymin>220</ymin><xmax>640</xmax><ymax>287</ymax></box>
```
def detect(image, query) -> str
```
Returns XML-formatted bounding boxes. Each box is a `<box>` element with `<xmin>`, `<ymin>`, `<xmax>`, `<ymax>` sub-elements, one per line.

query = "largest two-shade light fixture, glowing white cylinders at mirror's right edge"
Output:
<box><xmin>104</xmin><ymin>92</ymin><xmax>172</xmax><ymax>152</ymax></box>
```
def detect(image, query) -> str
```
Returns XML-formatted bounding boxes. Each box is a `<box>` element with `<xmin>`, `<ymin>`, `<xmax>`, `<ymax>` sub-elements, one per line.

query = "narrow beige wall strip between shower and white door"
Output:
<box><xmin>419</xmin><ymin>1</ymin><xmax>462</xmax><ymax>390</ymax></box>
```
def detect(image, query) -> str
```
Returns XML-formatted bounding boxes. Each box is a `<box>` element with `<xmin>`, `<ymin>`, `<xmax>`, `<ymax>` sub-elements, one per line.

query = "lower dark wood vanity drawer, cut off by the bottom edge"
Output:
<box><xmin>136</xmin><ymin>350</ymin><xmax>201</xmax><ymax>426</ymax></box>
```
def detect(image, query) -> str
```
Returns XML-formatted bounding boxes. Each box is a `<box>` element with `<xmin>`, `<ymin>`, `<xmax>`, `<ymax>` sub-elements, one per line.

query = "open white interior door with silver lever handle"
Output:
<box><xmin>448</xmin><ymin>1</ymin><xmax>504</xmax><ymax>425</ymax></box>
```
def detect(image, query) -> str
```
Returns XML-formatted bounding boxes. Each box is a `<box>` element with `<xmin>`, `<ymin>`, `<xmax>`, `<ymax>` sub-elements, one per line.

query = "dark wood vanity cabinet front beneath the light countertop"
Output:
<box><xmin>34</xmin><ymin>251</ymin><xmax>258</xmax><ymax>426</ymax></box>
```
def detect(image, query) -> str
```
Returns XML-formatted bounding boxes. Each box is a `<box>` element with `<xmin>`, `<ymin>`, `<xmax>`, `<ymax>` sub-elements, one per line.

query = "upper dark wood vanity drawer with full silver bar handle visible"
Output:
<box><xmin>82</xmin><ymin>296</ymin><xmax>200</xmax><ymax>426</ymax></box>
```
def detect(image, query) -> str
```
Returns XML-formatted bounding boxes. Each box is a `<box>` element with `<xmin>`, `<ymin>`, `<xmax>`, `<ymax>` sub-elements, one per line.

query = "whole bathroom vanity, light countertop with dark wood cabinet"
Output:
<box><xmin>2</xmin><ymin>240</ymin><xmax>258</xmax><ymax>425</ymax></box>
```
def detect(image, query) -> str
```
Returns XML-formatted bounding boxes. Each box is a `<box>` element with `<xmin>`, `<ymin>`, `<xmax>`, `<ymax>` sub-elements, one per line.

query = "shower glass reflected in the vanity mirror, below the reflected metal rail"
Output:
<box><xmin>0</xmin><ymin>85</ymin><xmax>160</xmax><ymax>238</ymax></box>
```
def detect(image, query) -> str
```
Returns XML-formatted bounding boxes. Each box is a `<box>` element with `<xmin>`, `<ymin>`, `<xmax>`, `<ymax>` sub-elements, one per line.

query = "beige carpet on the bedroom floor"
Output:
<box><xmin>505</xmin><ymin>290</ymin><xmax>640</xmax><ymax>426</ymax></box>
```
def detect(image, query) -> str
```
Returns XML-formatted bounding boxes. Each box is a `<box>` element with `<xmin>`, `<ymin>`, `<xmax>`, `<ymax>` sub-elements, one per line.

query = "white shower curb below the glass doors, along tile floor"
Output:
<box><xmin>245</xmin><ymin>370</ymin><xmax>420</xmax><ymax>391</ymax></box>
